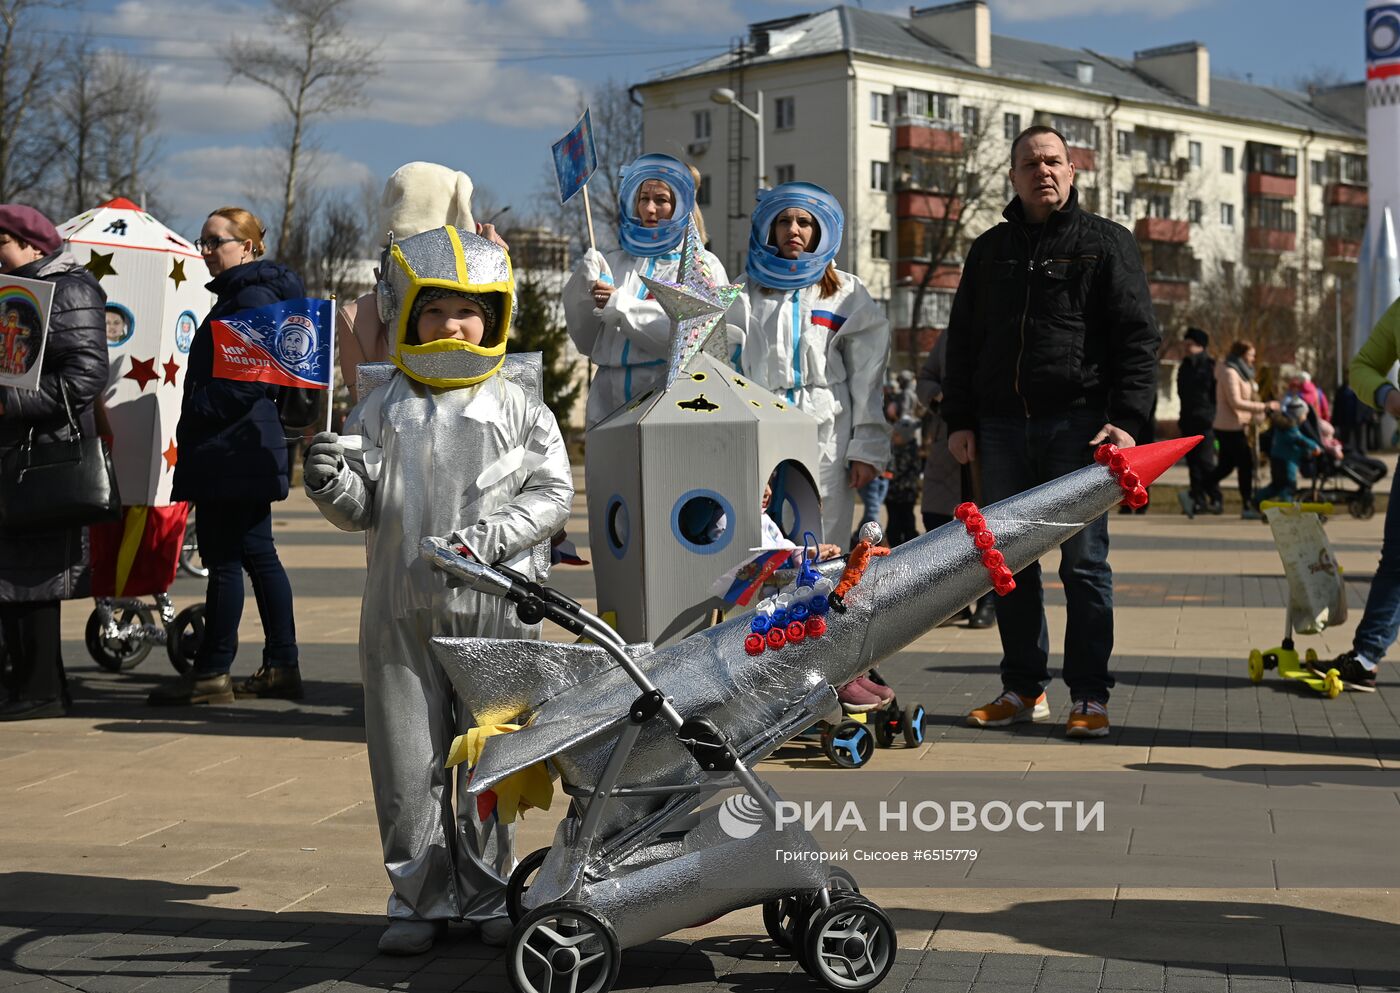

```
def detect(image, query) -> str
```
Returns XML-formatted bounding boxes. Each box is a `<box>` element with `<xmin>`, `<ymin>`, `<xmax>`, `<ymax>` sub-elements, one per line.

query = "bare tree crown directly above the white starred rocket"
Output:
<box><xmin>52</xmin><ymin>38</ymin><xmax>157</xmax><ymax>214</ymax></box>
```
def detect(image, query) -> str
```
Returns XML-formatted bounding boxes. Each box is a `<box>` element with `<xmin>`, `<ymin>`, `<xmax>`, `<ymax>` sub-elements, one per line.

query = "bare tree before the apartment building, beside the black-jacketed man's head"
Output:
<box><xmin>895</xmin><ymin>98</ymin><xmax>1005</xmax><ymax>368</ymax></box>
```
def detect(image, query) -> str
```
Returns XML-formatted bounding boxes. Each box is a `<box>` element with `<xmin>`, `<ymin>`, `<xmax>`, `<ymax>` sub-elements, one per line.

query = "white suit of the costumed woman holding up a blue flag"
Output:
<box><xmin>564</xmin><ymin>249</ymin><xmax>729</xmax><ymax>427</ymax></box>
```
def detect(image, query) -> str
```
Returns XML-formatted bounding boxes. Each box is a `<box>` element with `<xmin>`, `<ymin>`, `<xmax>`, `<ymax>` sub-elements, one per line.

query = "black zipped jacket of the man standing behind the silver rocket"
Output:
<box><xmin>942</xmin><ymin>190</ymin><xmax>1162</xmax><ymax>438</ymax></box>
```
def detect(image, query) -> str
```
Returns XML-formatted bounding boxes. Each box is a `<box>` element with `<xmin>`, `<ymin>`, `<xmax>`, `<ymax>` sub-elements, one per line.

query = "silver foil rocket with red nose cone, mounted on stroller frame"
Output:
<box><xmin>424</xmin><ymin>437</ymin><xmax>1200</xmax><ymax>957</ymax></box>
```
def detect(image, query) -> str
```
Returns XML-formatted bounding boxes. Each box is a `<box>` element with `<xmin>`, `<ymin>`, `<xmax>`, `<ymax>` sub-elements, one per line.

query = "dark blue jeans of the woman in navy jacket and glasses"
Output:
<box><xmin>195</xmin><ymin>500</ymin><xmax>297</xmax><ymax>675</ymax></box>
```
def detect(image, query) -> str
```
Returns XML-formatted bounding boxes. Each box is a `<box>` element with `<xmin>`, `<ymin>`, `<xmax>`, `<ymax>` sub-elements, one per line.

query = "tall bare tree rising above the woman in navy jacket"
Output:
<box><xmin>227</xmin><ymin>0</ymin><xmax>378</xmax><ymax>256</ymax></box>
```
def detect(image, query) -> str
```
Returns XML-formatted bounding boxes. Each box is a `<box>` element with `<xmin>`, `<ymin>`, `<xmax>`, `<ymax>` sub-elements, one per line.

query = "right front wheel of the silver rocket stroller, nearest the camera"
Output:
<box><xmin>802</xmin><ymin>896</ymin><xmax>896</xmax><ymax>990</ymax></box>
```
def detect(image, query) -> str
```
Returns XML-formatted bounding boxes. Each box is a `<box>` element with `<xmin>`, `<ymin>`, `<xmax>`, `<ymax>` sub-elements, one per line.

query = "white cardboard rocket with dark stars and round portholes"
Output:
<box><xmin>59</xmin><ymin>197</ymin><xmax>214</xmax><ymax>507</ymax></box>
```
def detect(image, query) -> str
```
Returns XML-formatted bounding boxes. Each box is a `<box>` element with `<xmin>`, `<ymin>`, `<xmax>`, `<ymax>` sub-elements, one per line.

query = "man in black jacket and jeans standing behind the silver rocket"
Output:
<box><xmin>942</xmin><ymin>126</ymin><xmax>1161</xmax><ymax>738</ymax></box>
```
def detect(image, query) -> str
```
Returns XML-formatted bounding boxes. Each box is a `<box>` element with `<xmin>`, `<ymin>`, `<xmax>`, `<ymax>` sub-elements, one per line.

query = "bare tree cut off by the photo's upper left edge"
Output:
<box><xmin>0</xmin><ymin>0</ymin><xmax>69</xmax><ymax>203</ymax></box>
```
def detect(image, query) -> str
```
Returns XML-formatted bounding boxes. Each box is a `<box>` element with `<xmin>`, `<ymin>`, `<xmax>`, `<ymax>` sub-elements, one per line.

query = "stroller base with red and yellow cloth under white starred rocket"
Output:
<box><xmin>84</xmin><ymin>503</ymin><xmax>207</xmax><ymax>672</ymax></box>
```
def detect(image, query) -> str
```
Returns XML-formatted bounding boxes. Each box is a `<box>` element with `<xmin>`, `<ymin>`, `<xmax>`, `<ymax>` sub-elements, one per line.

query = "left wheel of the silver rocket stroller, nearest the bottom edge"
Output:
<box><xmin>507</xmin><ymin>903</ymin><xmax>622</xmax><ymax>993</ymax></box>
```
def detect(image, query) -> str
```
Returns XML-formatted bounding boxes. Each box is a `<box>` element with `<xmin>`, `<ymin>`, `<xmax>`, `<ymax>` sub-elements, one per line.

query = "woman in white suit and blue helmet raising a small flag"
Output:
<box><xmin>564</xmin><ymin>154</ymin><xmax>728</xmax><ymax>427</ymax></box>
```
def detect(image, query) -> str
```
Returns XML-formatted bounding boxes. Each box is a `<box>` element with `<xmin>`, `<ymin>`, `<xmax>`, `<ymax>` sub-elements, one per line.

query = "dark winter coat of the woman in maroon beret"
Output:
<box><xmin>0</xmin><ymin>252</ymin><xmax>106</xmax><ymax>604</ymax></box>
